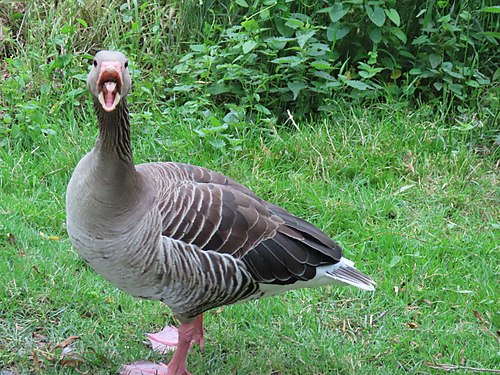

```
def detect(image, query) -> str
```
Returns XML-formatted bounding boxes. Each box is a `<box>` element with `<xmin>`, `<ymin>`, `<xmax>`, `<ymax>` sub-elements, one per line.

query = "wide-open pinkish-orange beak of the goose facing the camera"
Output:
<box><xmin>97</xmin><ymin>61</ymin><xmax>123</xmax><ymax>112</ymax></box>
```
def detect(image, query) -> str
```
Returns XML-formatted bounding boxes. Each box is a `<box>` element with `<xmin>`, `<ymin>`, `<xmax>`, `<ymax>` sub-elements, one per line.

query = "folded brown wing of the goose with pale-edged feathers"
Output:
<box><xmin>139</xmin><ymin>163</ymin><xmax>342</xmax><ymax>284</ymax></box>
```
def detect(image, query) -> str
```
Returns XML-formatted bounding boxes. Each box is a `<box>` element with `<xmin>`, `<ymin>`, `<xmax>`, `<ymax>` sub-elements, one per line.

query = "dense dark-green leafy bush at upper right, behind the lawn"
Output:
<box><xmin>171</xmin><ymin>0</ymin><xmax>500</xmax><ymax>116</ymax></box>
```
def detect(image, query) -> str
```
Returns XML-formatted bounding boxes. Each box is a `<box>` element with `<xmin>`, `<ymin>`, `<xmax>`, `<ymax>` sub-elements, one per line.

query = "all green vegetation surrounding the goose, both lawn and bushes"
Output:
<box><xmin>0</xmin><ymin>0</ymin><xmax>500</xmax><ymax>375</ymax></box>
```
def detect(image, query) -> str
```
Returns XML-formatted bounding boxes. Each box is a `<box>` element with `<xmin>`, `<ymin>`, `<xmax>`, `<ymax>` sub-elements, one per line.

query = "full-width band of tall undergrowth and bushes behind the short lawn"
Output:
<box><xmin>0</xmin><ymin>0</ymin><xmax>500</xmax><ymax>135</ymax></box>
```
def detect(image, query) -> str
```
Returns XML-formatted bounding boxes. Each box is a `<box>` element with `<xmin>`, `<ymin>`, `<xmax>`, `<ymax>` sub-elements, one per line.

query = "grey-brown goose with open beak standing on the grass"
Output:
<box><xmin>66</xmin><ymin>51</ymin><xmax>375</xmax><ymax>375</ymax></box>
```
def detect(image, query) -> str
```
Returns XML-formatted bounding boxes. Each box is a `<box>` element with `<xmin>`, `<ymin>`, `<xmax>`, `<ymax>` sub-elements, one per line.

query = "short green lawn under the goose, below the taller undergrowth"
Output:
<box><xmin>0</xmin><ymin>97</ymin><xmax>500</xmax><ymax>374</ymax></box>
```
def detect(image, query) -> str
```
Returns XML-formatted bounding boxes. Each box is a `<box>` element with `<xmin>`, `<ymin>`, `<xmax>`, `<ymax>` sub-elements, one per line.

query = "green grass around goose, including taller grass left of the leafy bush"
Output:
<box><xmin>0</xmin><ymin>1</ymin><xmax>500</xmax><ymax>375</ymax></box>
